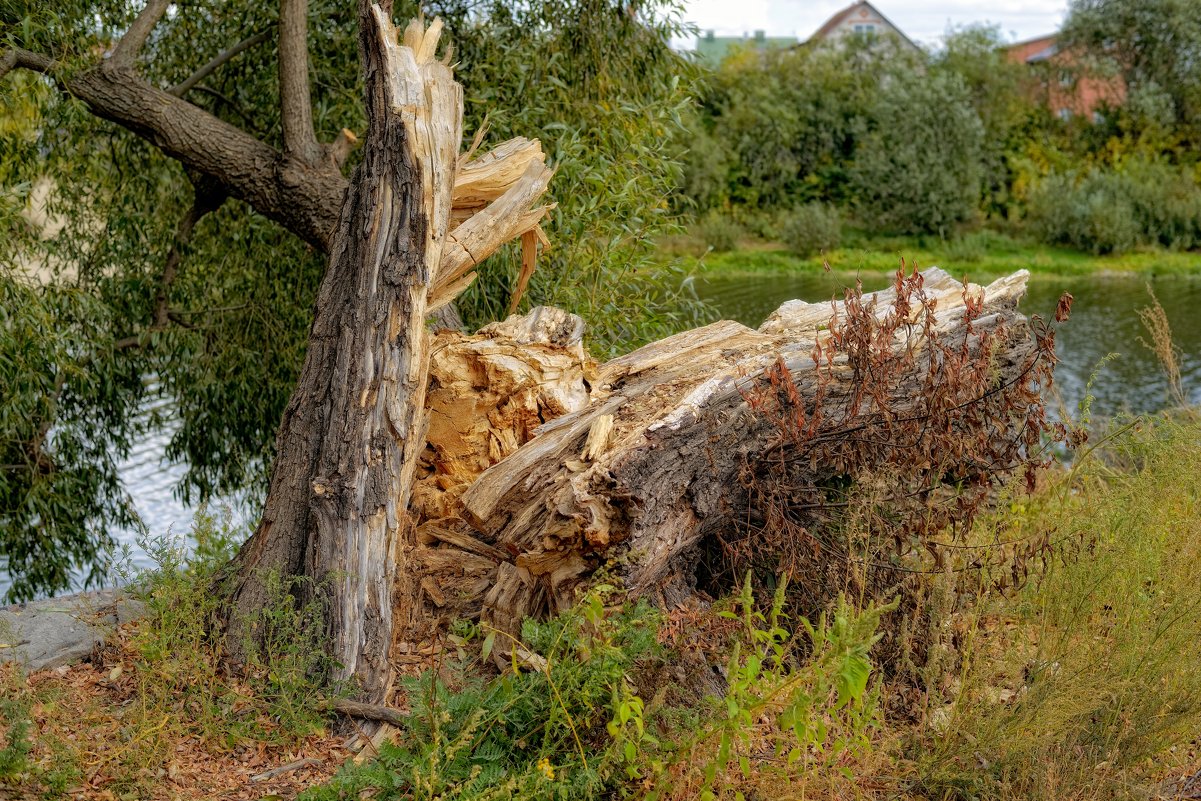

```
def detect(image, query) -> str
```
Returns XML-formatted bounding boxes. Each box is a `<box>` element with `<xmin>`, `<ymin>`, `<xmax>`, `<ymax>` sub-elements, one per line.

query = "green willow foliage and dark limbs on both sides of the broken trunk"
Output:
<box><xmin>0</xmin><ymin>0</ymin><xmax>689</xmax><ymax>599</ymax></box>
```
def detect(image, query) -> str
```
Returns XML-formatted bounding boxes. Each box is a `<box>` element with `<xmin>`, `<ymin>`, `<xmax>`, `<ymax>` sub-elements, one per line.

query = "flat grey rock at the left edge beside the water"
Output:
<box><xmin>0</xmin><ymin>590</ymin><xmax>145</xmax><ymax>670</ymax></box>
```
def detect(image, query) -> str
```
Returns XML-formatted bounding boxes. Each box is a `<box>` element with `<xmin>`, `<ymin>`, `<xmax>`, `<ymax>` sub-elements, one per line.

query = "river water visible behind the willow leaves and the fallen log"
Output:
<box><xmin>0</xmin><ymin>273</ymin><xmax>1201</xmax><ymax>597</ymax></box>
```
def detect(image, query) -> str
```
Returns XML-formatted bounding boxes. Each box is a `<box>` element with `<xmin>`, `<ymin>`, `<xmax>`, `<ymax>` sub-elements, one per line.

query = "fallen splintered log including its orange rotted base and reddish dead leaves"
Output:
<box><xmin>398</xmin><ymin>269</ymin><xmax>1053</xmax><ymax>652</ymax></box>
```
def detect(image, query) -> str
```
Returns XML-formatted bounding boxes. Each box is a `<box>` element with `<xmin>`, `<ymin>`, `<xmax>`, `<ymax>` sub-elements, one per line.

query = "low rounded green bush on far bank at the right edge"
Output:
<box><xmin>1029</xmin><ymin>159</ymin><xmax>1201</xmax><ymax>253</ymax></box>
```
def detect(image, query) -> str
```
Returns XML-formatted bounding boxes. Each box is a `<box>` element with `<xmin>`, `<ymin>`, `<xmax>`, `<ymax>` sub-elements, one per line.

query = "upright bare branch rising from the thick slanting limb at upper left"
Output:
<box><xmin>280</xmin><ymin>0</ymin><xmax>321</xmax><ymax>165</ymax></box>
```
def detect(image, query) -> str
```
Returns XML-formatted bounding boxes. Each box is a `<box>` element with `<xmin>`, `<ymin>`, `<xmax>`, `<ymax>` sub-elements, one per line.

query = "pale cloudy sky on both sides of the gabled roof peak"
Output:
<box><xmin>685</xmin><ymin>0</ymin><xmax>1068</xmax><ymax>44</ymax></box>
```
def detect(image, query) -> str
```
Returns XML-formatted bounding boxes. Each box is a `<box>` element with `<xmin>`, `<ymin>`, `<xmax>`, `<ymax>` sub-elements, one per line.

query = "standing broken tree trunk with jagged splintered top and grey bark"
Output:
<box><xmin>227</xmin><ymin>10</ymin><xmax>550</xmax><ymax>701</ymax></box>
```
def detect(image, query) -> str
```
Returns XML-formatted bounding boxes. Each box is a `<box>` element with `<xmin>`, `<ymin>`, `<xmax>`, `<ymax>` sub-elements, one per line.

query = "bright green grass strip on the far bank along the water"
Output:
<box><xmin>661</xmin><ymin>232</ymin><xmax>1201</xmax><ymax>277</ymax></box>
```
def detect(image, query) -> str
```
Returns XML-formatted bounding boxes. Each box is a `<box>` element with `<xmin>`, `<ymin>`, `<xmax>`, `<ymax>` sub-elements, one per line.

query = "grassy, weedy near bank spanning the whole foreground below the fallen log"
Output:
<box><xmin>0</xmin><ymin>413</ymin><xmax>1201</xmax><ymax>801</ymax></box>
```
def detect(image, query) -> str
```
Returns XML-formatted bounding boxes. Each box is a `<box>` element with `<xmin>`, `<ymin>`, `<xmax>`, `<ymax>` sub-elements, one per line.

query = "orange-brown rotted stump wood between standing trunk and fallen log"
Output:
<box><xmin>393</xmin><ymin>306</ymin><xmax>596</xmax><ymax>643</ymax></box>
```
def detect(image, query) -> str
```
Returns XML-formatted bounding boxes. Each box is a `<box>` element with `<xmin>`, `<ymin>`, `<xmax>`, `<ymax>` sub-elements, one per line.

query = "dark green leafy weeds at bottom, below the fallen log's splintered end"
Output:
<box><xmin>301</xmin><ymin>588</ymin><xmax>656</xmax><ymax>801</ymax></box>
